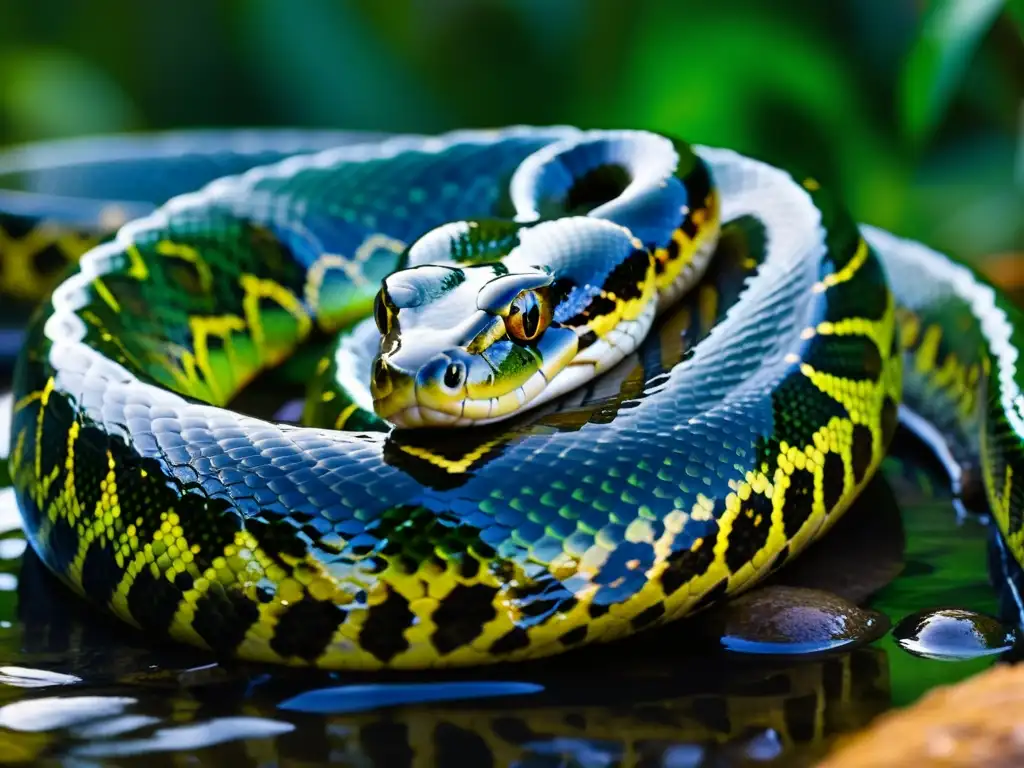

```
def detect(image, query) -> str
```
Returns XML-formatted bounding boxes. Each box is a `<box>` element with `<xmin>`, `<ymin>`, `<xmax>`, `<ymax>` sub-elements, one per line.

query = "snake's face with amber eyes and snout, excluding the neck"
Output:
<box><xmin>371</xmin><ymin>257</ymin><xmax>577</xmax><ymax>427</ymax></box>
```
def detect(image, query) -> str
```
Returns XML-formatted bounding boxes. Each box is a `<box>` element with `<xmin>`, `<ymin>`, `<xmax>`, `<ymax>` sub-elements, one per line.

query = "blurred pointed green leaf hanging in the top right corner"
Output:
<box><xmin>900</xmin><ymin>0</ymin><xmax>1003</xmax><ymax>143</ymax></box>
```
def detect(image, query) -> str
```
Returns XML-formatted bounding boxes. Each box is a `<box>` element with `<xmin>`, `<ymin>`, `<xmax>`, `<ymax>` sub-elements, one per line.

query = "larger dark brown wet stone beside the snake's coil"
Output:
<box><xmin>711</xmin><ymin>586</ymin><xmax>889</xmax><ymax>655</ymax></box>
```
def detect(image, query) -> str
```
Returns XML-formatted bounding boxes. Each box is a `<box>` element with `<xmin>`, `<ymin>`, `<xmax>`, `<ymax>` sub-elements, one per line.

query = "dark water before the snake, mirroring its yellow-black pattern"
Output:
<box><xmin>0</xmin><ymin>495</ymin><xmax>890</xmax><ymax>768</ymax></box>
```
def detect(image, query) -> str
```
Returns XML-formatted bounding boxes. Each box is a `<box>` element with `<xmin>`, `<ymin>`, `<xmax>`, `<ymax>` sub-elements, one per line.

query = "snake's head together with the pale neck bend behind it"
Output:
<box><xmin>370</xmin><ymin>217</ymin><xmax>653</xmax><ymax>434</ymax></box>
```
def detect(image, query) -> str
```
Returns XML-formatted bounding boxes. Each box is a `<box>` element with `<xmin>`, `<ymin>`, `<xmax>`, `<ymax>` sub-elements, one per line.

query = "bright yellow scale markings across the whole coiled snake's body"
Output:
<box><xmin>4</xmin><ymin>166</ymin><xmax>905</xmax><ymax>669</ymax></box>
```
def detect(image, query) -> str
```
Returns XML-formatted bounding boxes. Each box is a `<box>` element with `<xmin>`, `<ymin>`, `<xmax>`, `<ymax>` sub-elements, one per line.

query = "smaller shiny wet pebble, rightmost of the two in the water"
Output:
<box><xmin>893</xmin><ymin>608</ymin><xmax>1016</xmax><ymax>662</ymax></box>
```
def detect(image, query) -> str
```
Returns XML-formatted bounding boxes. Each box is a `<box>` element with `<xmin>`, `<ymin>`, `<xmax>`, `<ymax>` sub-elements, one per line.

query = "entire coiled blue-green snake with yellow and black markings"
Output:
<box><xmin>0</xmin><ymin>126</ymin><xmax>1024</xmax><ymax>670</ymax></box>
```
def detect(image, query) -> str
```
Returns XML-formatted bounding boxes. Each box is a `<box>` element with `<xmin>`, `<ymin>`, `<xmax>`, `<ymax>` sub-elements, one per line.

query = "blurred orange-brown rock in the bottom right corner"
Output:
<box><xmin>818</xmin><ymin>665</ymin><xmax>1024</xmax><ymax>768</ymax></box>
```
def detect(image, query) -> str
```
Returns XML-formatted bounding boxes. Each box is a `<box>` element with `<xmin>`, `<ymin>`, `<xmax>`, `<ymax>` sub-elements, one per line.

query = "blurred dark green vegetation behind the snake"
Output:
<box><xmin>0</xmin><ymin>0</ymin><xmax>1024</xmax><ymax>284</ymax></box>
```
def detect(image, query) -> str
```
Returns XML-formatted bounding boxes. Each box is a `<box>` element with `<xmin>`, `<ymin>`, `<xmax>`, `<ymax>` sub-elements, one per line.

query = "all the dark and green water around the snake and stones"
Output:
<box><xmin>0</xmin><ymin>385</ymin><xmax>998</xmax><ymax>768</ymax></box>
